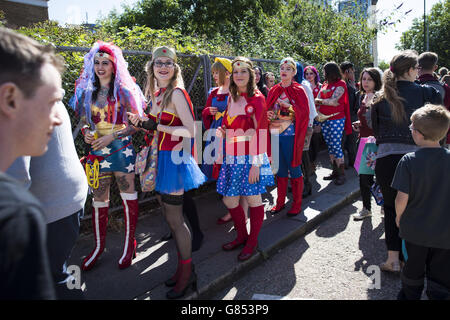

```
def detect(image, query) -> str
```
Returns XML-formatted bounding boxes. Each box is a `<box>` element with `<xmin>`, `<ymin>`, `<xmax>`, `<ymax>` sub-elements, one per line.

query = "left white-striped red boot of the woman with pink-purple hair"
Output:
<box><xmin>81</xmin><ymin>201</ymin><xmax>109</xmax><ymax>271</ymax></box>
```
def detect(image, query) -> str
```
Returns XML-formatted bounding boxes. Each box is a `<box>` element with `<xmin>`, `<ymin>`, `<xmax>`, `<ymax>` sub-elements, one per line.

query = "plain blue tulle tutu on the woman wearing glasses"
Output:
<box><xmin>155</xmin><ymin>150</ymin><xmax>207</xmax><ymax>194</ymax></box>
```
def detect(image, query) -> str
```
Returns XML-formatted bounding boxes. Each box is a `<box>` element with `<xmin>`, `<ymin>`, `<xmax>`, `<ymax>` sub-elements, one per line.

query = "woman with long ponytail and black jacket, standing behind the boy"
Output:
<box><xmin>371</xmin><ymin>50</ymin><xmax>442</xmax><ymax>273</ymax></box>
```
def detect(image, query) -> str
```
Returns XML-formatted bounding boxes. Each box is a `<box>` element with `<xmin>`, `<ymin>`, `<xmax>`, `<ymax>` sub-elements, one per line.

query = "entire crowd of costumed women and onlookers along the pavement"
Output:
<box><xmin>0</xmin><ymin>28</ymin><xmax>450</xmax><ymax>299</ymax></box>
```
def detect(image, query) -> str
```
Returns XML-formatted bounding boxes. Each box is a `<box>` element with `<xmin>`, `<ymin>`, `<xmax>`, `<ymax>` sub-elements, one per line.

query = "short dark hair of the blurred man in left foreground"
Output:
<box><xmin>0</xmin><ymin>27</ymin><xmax>64</xmax><ymax>98</ymax></box>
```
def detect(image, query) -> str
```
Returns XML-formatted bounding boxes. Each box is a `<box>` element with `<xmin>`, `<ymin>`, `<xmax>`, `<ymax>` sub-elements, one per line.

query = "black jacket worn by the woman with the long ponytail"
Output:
<box><xmin>371</xmin><ymin>81</ymin><xmax>442</xmax><ymax>144</ymax></box>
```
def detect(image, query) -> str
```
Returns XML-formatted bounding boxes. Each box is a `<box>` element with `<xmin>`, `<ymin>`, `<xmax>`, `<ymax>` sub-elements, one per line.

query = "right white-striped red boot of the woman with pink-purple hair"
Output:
<box><xmin>119</xmin><ymin>193</ymin><xmax>139</xmax><ymax>269</ymax></box>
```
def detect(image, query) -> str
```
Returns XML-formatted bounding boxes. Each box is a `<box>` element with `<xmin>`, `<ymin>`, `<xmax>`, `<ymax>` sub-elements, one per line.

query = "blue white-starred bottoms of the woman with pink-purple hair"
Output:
<box><xmin>91</xmin><ymin>137</ymin><xmax>136</xmax><ymax>173</ymax></box>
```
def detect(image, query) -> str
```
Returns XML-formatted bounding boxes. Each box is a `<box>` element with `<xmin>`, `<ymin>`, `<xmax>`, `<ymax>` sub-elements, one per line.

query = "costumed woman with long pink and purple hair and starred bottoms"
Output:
<box><xmin>69</xmin><ymin>41</ymin><xmax>145</xmax><ymax>270</ymax></box>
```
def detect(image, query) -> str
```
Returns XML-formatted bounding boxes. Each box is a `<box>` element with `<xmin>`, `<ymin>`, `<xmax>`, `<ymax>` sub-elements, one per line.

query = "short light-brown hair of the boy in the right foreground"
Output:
<box><xmin>411</xmin><ymin>104</ymin><xmax>450</xmax><ymax>142</ymax></box>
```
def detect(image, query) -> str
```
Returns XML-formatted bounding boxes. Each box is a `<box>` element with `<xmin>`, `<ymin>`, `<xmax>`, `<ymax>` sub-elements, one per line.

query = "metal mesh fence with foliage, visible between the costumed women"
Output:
<box><xmin>57</xmin><ymin>47</ymin><xmax>280</xmax><ymax>219</ymax></box>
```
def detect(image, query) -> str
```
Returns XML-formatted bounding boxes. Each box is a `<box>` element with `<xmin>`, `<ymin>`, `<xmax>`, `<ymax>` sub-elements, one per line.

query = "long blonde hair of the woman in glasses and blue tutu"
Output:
<box><xmin>144</xmin><ymin>60</ymin><xmax>184</xmax><ymax>110</ymax></box>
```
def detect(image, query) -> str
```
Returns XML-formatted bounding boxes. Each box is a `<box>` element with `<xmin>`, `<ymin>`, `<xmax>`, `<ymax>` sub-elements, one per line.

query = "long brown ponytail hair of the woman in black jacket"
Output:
<box><xmin>374</xmin><ymin>50</ymin><xmax>419</xmax><ymax>124</ymax></box>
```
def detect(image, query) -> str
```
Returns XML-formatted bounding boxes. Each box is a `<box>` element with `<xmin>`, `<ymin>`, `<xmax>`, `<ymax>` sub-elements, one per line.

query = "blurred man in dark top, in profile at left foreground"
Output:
<box><xmin>0</xmin><ymin>27</ymin><xmax>64</xmax><ymax>300</ymax></box>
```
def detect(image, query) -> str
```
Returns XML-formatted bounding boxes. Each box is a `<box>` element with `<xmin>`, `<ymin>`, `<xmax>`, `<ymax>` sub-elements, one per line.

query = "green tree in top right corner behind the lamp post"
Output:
<box><xmin>397</xmin><ymin>0</ymin><xmax>450</xmax><ymax>67</ymax></box>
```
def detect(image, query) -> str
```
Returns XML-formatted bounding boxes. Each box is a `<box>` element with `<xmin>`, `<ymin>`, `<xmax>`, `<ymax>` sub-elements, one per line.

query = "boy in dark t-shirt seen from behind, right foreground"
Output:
<box><xmin>392</xmin><ymin>104</ymin><xmax>450</xmax><ymax>300</ymax></box>
